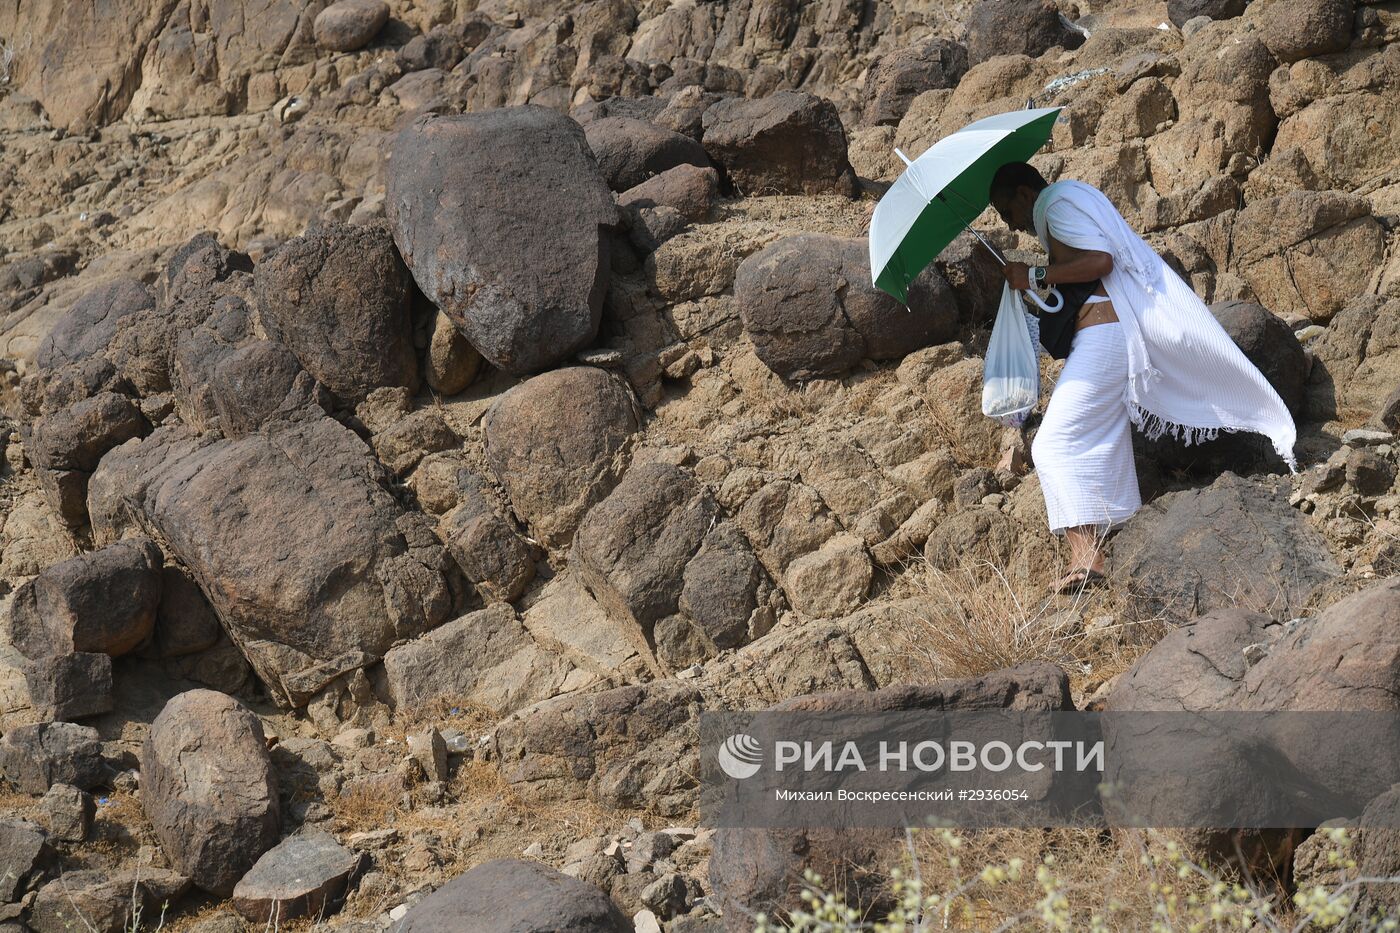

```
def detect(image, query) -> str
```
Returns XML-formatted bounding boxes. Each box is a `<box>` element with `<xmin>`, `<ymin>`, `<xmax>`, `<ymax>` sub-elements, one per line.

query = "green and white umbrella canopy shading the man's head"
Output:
<box><xmin>869</xmin><ymin>106</ymin><xmax>1060</xmax><ymax>303</ymax></box>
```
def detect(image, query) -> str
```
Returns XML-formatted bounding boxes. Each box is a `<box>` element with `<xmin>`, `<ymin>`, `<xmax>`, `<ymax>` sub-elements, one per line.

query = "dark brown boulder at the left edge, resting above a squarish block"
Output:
<box><xmin>10</xmin><ymin>538</ymin><xmax>164</xmax><ymax>658</ymax></box>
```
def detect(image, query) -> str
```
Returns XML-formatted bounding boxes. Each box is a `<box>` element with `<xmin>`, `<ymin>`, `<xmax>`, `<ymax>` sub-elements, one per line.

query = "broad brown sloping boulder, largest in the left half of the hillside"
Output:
<box><xmin>90</xmin><ymin>412</ymin><xmax>462</xmax><ymax>706</ymax></box>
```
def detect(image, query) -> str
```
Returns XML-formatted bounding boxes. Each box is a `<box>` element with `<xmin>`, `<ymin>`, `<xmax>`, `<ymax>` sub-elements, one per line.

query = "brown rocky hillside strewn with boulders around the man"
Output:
<box><xmin>0</xmin><ymin>0</ymin><xmax>1400</xmax><ymax>933</ymax></box>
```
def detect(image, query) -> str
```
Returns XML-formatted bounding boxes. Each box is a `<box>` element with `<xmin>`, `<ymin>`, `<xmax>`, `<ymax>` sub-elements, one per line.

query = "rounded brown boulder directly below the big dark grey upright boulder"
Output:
<box><xmin>484</xmin><ymin>366</ymin><xmax>640</xmax><ymax>546</ymax></box>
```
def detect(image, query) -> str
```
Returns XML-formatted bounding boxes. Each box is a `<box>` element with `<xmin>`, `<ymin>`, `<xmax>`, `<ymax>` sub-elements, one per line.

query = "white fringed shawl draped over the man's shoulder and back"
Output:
<box><xmin>1035</xmin><ymin>181</ymin><xmax>1298</xmax><ymax>474</ymax></box>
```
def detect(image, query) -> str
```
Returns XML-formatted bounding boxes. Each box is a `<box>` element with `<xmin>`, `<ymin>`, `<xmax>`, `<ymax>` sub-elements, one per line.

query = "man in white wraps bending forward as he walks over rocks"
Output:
<box><xmin>991</xmin><ymin>163</ymin><xmax>1298</xmax><ymax>593</ymax></box>
